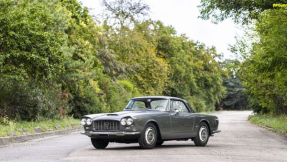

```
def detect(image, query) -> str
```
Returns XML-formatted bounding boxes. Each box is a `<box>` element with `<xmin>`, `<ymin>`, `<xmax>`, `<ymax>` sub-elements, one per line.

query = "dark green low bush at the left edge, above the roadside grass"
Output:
<box><xmin>0</xmin><ymin>79</ymin><xmax>69</xmax><ymax>121</ymax></box>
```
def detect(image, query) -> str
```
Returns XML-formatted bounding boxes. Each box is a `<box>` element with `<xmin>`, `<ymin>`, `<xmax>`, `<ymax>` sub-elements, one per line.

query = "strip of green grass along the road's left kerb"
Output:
<box><xmin>0</xmin><ymin>117</ymin><xmax>80</xmax><ymax>137</ymax></box>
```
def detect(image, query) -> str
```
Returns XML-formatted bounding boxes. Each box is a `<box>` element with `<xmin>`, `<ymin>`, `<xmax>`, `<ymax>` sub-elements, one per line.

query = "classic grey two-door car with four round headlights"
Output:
<box><xmin>81</xmin><ymin>96</ymin><xmax>220</xmax><ymax>149</ymax></box>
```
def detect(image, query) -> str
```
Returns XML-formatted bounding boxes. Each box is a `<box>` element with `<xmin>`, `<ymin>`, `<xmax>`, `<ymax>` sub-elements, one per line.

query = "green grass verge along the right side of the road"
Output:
<box><xmin>248</xmin><ymin>114</ymin><xmax>287</xmax><ymax>135</ymax></box>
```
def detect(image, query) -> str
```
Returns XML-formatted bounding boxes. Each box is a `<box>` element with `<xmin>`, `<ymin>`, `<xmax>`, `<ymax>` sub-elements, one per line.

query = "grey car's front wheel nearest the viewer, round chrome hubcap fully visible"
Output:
<box><xmin>138</xmin><ymin>123</ymin><xmax>157</xmax><ymax>149</ymax></box>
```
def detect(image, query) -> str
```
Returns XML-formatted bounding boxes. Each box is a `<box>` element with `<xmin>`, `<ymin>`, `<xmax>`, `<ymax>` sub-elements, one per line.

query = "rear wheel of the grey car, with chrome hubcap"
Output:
<box><xmin>194</xmin><ymin>122</ymin><xmax>209</xmax><ymax>146</ymax></box>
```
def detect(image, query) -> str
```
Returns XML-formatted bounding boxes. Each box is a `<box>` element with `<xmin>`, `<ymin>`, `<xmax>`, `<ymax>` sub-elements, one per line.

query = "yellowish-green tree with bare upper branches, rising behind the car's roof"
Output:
<box><xmin>100</xmin><ymin>0</ymin><xmax>168</xmax><ymax>95</ymax></box>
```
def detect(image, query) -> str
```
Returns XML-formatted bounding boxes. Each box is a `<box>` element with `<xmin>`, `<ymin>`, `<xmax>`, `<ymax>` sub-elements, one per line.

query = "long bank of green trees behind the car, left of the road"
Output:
<box><xmin>0</xmin><ymin>0</ymin><xmax>225</xmax><ymax>121</ymax></box>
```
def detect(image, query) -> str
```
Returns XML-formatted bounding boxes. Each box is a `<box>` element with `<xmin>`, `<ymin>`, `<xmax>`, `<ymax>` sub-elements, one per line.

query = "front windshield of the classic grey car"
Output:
<box><xmin>125</xmin><ymin>99</ymin><xmax>168</xmax><ymax>111</ymax></box>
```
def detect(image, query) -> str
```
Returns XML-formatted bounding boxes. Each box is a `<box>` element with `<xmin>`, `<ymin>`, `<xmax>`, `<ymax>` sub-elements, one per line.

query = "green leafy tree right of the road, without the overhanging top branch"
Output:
<box><xmin>241</xmin><ymin>9</ymin><xmax>287</xmax><ymax>114</ymax></box>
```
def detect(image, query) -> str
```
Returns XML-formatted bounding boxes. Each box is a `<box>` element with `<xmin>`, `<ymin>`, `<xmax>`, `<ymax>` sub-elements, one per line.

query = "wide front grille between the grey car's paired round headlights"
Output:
<box><xmin>93</xmin><ymin>120</ymin><xmax>120</xmax><ymax>130</ymax></box>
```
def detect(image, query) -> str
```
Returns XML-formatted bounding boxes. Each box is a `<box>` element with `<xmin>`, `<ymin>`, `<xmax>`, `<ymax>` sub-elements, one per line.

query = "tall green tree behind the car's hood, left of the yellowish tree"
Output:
<box><xmin>59</xmin><ymin>0</ymin><xmax>137</xmax><ymax>117</ymax></box>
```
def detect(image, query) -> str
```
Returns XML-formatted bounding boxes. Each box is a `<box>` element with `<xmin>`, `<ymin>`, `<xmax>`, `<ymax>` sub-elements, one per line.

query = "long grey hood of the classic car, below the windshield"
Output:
<box><xmin>84</xmin><ymin>110</ymin><xmax>160</xmax><ymax>120</ymax></box>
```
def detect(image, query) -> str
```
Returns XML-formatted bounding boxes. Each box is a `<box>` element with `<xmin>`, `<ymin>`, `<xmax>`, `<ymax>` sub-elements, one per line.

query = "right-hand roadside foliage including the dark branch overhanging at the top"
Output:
<box><xmin>200</xmin><ymin>0</ymin><xmax>287</xmax><ymax>114</ymax></box>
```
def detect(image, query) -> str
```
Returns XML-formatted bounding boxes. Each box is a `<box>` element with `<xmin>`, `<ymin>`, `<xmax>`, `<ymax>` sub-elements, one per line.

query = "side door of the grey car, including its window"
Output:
<box><xmin>170</xmin><ymin>100</ymin><xmax>194</xmax><ymax>138</ymax></box>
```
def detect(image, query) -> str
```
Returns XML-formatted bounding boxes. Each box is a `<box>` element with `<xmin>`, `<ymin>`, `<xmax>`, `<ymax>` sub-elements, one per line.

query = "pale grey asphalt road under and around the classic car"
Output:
<box><xmin>0</xmin><ymin>111</ymin><xmax>287</xmax><ymax>162</ymax></box>
